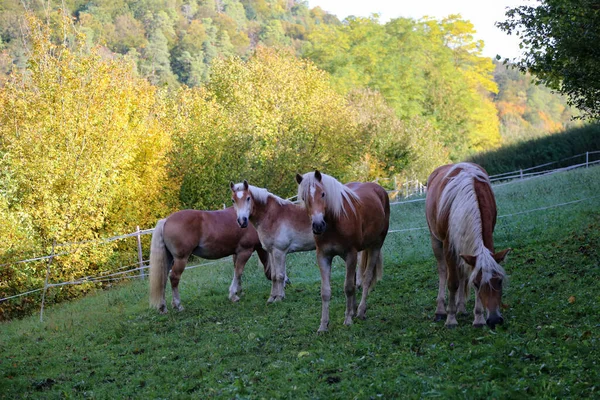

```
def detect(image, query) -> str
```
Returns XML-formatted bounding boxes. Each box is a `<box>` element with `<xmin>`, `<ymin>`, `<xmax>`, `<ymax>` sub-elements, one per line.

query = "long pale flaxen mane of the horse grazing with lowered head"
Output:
<box><xmin>438</xmin><ymin>163</ymin><xmax>506</xmax><ymax>285</ymax></box>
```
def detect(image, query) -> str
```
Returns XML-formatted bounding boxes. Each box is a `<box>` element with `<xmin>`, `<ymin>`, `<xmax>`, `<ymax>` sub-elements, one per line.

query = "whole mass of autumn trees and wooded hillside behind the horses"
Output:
<box><xmin>0</xmin><ymin>0</ymin><xmax>592</xmax><ymax>318</ymax></box>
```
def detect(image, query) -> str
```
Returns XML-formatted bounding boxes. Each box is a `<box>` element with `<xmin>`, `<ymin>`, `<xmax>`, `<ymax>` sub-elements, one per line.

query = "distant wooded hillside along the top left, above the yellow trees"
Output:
<box><xmin>0</xmin><ymin>0</ymin><xmax>337</xmax><ymax>86</ymax></box>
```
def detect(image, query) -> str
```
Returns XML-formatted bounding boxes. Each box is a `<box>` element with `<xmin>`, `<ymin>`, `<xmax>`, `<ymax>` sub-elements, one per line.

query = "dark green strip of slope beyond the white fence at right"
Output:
<box><xmin>469</xmin><ymin>125</ymin><xmax>600</xmax><ymax>175</ymax></box>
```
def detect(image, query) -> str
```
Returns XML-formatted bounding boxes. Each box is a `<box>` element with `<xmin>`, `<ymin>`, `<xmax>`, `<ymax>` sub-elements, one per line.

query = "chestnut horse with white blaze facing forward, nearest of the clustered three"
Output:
<box><xmin>296</xmin><ymin>170</ymin><xmax>390</xmax><ymax>332</ymax></box>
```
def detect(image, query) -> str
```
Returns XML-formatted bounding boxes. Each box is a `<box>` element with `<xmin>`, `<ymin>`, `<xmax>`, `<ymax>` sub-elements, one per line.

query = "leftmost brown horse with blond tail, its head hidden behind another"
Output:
<box><xmin>150</xmin><ymin>207</ymin><xmax>271</xmax><ymax>314</ymax></box>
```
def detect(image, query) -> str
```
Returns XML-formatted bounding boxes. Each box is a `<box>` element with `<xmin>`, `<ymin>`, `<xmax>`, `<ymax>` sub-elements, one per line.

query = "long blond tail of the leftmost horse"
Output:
<box><xmin>150</xmin><ymin>219</ymin><xmax>168</xmax><ymax>309</ymax></box>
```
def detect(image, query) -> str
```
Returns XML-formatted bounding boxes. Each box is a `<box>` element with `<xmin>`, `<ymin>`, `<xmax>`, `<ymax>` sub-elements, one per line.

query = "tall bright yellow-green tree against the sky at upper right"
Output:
<box><xmin>303</xmin><ymin>16</ymin><xmax>500</xmax><ymax>159</ymax></box>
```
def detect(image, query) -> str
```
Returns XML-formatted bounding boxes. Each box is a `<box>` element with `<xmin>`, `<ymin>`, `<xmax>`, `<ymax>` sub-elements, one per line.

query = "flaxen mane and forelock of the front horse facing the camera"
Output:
<box><xmin>298</xmin><ymin>172</ymin><xmax>360</xmax><ymax>218</ymax></box>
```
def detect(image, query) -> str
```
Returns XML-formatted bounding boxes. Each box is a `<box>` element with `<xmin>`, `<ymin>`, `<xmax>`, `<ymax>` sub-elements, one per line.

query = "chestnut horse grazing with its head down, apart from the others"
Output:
<box><xmin>425</xmin><ymin>163</ymin><xmax>510</xmax><ymax>329</ymax></box>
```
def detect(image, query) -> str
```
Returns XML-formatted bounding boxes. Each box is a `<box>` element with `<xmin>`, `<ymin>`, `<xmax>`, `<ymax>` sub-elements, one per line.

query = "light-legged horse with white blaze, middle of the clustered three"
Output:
<box><xmin>229</xmin><ymin>181</ymin><xmax>315</xmax><ymax>303</ymax></box>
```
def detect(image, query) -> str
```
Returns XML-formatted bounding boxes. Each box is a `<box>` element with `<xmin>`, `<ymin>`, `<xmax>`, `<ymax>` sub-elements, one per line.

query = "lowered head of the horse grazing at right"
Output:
<box><xmin>461</xmin><ymin>249</ymin><xmax>511</xmax><ymax>329</ymax></box>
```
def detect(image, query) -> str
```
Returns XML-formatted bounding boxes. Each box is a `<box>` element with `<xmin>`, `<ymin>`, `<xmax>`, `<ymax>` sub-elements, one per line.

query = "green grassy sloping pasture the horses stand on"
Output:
<box><xmin>0</xmin><ymin>167</ymin><xmax>600</xmax><ymax>399</ymax></box>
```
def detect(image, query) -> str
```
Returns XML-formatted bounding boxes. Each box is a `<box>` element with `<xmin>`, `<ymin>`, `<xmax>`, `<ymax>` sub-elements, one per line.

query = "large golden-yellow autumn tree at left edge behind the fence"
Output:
<box><xmin>0</xmin><ymin>15</ymin><xmax>170</xmax><ymax>310</ymax></box>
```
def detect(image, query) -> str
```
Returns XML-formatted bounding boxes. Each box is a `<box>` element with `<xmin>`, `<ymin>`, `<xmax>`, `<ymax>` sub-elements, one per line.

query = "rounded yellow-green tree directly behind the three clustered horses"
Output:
<box><xmin>173</xmin><ymin>48</ymin><xmax>362</xmax><ymax>208</ymax></box>
